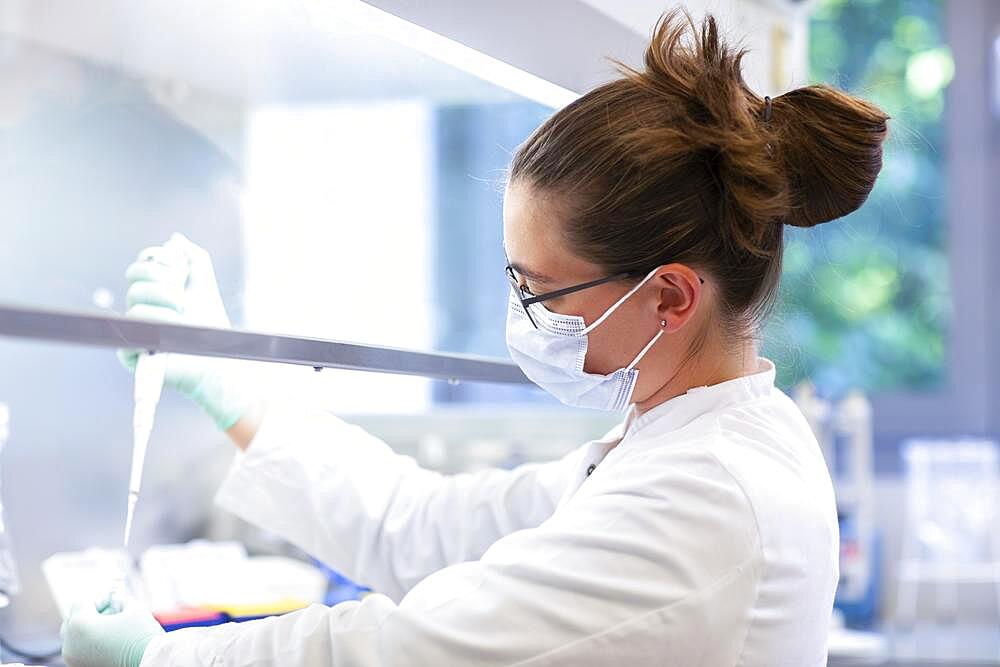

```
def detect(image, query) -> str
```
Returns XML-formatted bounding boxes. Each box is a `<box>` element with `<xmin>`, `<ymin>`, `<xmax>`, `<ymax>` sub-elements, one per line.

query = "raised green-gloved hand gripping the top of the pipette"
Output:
<box><xmin>118</xmin><ymin>234</ymin><xmax>256</xmax><ymax>431</ymax></box>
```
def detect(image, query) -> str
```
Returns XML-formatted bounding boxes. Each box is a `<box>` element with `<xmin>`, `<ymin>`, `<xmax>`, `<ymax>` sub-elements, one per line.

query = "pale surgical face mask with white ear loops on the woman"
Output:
<box><xmin>507</xmin><ymin>270</ymin><xmax>663</xmax><ymax>411</ymax></box>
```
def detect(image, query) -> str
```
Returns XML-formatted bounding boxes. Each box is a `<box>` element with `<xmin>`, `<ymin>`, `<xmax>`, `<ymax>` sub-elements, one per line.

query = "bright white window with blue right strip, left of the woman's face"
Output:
<box><xmin>244</xmin><ymin>96</ymin><xmax>551</xmax><ymax>412</ymax></box>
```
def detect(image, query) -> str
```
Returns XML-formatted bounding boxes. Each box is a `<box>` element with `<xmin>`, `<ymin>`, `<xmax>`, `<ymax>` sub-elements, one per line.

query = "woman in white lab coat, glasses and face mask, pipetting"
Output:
<box><xmin>64</xmin><ymin>14</ymin><xmax>887</xmax><ymax>667</ymax></box>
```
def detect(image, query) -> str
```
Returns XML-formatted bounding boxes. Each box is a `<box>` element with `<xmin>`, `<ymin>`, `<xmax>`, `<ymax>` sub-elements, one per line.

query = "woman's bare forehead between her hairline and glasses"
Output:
<box><xmin>503</xmin><ymin>182</ymin><xmax>601</xmax><ymax>281</ymax></box>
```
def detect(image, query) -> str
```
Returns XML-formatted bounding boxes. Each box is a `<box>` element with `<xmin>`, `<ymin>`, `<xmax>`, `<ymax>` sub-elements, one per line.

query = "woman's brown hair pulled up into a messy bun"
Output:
<box><xmin>509</xmin><ymin>10</ymin><xmax>889</xmax><ymax>344</ymax></box>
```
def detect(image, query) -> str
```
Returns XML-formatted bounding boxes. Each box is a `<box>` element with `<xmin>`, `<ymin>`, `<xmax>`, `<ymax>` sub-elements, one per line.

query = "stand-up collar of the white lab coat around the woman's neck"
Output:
<box><xmin>622</xmin><ymin>357</ymin><xmax>775</xmax><ymax>438</ymax></box>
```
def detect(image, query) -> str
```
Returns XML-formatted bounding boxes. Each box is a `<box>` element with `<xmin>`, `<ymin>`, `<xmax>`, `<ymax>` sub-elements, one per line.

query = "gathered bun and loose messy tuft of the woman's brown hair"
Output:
<box><xmin>624</xmin><ymin>10</ymin><xmax>888</xmax><ymax>254</ymax></box>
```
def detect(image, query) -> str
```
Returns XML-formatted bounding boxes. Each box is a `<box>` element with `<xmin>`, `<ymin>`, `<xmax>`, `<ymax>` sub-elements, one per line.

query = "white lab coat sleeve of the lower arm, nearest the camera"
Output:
<box><xmin>141</xmin><ymin>444</ymin><xmax>762</xmax><ymax>667</ymax></box>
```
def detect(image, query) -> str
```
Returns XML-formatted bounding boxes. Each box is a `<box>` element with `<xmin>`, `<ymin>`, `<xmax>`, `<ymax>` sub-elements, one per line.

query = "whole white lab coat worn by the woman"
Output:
<box><xmin>142</xmin><ymin>359</ymin><xmax>838</xmax><ymax>667</ymax></box>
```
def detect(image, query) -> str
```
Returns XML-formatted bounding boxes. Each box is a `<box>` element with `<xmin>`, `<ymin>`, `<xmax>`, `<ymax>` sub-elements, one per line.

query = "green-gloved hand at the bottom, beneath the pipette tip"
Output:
<box><xmin>59</xmin><ymin>600</ymin><xmax>163</xmax><ymax>667</ymax></box>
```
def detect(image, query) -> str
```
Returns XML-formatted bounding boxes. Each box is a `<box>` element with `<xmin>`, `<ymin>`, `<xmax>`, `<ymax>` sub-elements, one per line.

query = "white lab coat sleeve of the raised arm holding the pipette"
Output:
<box><xmin>216</xmin><ymin>408</ymin><xmax>580</xmax><ymax>601</ymax></box>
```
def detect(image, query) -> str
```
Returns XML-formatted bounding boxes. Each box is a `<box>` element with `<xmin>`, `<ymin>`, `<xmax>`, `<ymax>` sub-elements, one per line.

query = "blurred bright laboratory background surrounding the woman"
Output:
<box><xmin>0</xmin><ymin>0</ymin><xmax>1000</xmax><ymax>664</ymax></box>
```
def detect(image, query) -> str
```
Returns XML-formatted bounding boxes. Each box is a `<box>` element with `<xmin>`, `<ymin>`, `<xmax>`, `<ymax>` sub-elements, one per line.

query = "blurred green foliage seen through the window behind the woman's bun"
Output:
<box><xmin>763</xmin><ymin>0</ymin><xmax>954</xmax><ymax>393</ymax></box>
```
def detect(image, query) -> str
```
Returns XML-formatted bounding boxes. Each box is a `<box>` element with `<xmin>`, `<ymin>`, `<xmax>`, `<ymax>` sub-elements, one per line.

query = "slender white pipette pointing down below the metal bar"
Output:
<box><xmin>108</xmin><ymin>353</ymin><xmax>167</xmax><ymax>609</ymax></box>
